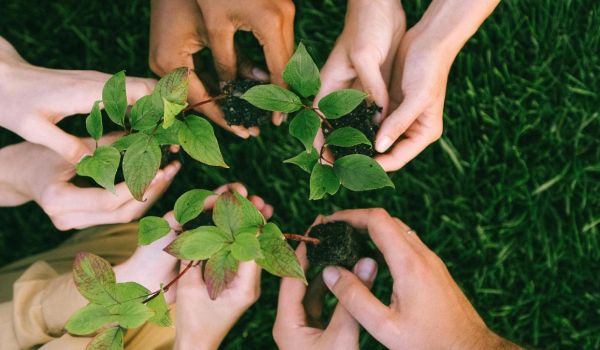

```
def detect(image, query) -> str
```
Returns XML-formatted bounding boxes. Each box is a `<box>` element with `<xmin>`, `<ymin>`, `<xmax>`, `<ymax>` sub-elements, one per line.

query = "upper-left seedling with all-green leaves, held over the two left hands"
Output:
<box><xmin>77</xmin><ymin>67</ymin><xmax>227</xmax><ymax>201</ymax></box>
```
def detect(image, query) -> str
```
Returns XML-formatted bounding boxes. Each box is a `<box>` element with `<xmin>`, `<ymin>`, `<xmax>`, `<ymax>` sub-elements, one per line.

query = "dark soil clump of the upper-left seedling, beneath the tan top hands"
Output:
<box><xmin>219</xmin><ymin>79</ymin><xmax>271</xmax><ymax>128</ymax></box>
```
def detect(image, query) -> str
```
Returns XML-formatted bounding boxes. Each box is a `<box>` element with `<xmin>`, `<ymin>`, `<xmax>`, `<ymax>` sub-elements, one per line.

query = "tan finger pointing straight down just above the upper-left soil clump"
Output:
<box><xmin>208</xmin><ymin>24</ymin><xmax>237</xmax><ymax>82</ymax></box>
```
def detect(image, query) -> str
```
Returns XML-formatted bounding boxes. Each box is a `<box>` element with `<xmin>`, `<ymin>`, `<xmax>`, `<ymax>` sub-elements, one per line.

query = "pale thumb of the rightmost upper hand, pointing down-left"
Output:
<box><xmin>375</xmin><ymin>96</ymin><xmax>427</xmax><ymax>153</ymax></box>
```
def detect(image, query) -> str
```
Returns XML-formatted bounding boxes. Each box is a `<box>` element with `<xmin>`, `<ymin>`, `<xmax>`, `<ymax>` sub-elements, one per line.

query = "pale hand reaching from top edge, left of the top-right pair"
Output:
<box><xmin>315</xmin><ymin>0</ymin><xmax>406</xmax><ymax>159</ymax></box>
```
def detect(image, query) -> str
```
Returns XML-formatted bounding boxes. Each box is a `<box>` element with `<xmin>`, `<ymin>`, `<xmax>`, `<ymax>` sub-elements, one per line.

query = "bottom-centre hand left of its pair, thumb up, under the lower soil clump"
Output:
<box><xmin>273</xmin><ymin>217</ymin><xmax>377</xmax><ymax>350</ymax></box>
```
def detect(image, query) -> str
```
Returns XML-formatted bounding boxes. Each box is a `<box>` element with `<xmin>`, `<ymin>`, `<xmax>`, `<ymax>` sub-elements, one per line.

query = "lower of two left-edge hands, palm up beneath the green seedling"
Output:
<box><xmin>0</xmin><ymin>134</ymin><xmax>181</xmax><ymax>230</ymax></box>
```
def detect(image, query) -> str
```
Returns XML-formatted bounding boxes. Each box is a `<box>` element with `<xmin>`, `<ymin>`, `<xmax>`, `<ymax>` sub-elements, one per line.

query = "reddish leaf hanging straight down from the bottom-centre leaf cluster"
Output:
<box><xmin>204</xmin><ymin>248</ymin><xmax>239</xmax><ymax>300</ymax></box>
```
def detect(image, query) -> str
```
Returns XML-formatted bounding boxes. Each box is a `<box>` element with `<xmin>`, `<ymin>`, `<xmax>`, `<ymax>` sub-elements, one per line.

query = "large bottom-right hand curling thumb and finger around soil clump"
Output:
<box><xmin>323</xmin><ymin>209</ymin><xmax>518</xmax><ymax>349</ymax></box>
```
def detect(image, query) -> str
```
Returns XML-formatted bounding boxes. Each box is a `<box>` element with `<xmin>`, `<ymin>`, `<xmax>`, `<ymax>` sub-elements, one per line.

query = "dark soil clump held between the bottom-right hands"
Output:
<box><xmin>306</xmin><ymin>222</ymin><xmax>368</xmax><ymax>269</ymax></box>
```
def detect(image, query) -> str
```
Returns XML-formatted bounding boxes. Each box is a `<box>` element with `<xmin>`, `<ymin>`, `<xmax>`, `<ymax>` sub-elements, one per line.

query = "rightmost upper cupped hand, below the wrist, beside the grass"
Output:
<box><xmin>375</xmin><ymin>29</ymin><xmax>454</xmax><ymax>171</ymax></box>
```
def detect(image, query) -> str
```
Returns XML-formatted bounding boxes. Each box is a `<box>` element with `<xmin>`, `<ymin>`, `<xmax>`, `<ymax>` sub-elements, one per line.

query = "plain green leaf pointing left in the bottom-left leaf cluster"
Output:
<box><xmin>65</xmin><ymin>304</ymin><xmax>117</xmax><ymax>335</ymax></box>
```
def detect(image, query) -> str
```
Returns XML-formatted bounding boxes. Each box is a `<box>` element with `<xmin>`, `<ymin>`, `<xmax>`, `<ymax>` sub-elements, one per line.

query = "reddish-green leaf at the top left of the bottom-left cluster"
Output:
<box><xmin>73</xmin><ymin>253</ymin><xmax>117</xmax><ymax>305</ymax></box>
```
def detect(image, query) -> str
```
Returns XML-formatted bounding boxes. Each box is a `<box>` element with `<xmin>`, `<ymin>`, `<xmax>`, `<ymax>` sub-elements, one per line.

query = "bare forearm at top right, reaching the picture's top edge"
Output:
<box><xmin>411</xmin><ymin>0</ymin><xmax>500</xmax><ymax>60</ymax></box>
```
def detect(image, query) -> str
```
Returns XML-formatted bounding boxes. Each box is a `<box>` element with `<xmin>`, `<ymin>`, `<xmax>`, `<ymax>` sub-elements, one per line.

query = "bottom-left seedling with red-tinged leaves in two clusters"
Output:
<box><xmin>65</xmin><ymin>189</ymin><xmax>306</xmax><ymax>350</ymax></box>
